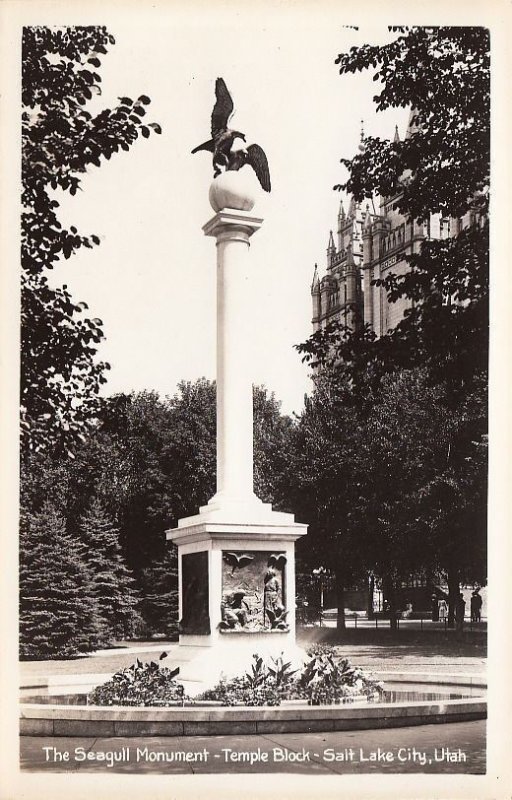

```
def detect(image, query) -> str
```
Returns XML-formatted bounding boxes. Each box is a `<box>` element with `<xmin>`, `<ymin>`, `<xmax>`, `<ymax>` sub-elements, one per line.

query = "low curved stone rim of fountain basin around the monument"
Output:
<box><xmin>20</xmin><ymin>673</ymin><xmax>487</xmax><ymax>737</ymax></box>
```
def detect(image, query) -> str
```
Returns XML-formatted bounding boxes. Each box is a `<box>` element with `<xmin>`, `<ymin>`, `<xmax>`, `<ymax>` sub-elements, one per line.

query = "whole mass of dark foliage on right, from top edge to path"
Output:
<box><xmin>292</xmin><ymin>27</ymin><xmax>490</xmax><ymax>603</ymax></box>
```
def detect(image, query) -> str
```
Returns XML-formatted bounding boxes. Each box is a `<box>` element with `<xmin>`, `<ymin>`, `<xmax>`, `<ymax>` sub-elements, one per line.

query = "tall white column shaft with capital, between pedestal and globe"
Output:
<box><xmin>203</xmin><ymin>209</ymin><xmax>262</xmax><ymax>506</ymax></box>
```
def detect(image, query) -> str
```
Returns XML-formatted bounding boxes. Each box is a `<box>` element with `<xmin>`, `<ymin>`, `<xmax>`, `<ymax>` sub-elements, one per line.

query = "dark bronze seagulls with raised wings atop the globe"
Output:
<box><xmin>192</xmin><ymin>78</ymin><xmax>270</xmax><ymax>192</ymax></box>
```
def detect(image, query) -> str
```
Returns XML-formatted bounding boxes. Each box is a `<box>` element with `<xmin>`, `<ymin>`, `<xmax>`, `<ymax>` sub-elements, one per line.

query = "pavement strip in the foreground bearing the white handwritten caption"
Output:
<box><xmin>20</xmin><ymin>720</ymin><xmax>486</xmax><ymax>772</ymax></box>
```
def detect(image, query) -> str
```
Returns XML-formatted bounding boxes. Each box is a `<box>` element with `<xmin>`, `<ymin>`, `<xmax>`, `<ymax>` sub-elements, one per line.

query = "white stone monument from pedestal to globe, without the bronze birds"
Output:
<box><xmin>167</xmin><ymin>171</ymin><xmax>307</xmax><ymax>683</ymax></box>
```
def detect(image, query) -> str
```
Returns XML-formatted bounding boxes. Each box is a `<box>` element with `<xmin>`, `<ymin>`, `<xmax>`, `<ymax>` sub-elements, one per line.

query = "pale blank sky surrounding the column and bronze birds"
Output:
<box><xmin>52</xmin><ymin>12</ymin><xmax>407</xmax><ymax>413</ymax></box>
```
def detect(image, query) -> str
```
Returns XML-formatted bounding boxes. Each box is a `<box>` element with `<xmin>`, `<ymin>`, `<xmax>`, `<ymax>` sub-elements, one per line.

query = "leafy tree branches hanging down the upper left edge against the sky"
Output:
<box><xmin>21</xmin><ymin>26</ymin><xmax>161</xmax><ymax>450</ymax></box>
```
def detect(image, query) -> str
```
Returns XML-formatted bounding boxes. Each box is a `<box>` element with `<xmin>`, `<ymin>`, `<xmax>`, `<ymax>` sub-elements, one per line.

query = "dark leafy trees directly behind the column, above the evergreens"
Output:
<box><xmin>21</xmin><ymin>379</ymin><xmax>291</xmax><ymax>636</ymax></box>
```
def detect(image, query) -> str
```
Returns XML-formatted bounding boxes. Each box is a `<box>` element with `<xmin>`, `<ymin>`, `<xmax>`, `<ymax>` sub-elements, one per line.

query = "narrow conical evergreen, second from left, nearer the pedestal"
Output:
<box><xmin>80</xmin><ymin>499</ymin><xmax>137</xmax><ymax>644</ymax></box>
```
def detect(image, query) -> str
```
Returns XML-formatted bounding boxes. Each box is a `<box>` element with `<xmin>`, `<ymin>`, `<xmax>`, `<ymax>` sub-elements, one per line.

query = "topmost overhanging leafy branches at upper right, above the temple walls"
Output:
<box><xmin>336</xmin><ymin>27</ymin><xmax>490</xmax><ymax>220</ymax></box>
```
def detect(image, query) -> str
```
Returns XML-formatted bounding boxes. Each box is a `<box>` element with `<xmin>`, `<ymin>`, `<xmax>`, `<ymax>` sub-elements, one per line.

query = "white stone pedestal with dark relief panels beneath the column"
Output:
<box><xmin>167</xmin><ymin>496</ymin><xmax>307</xmax><ymax>693</ymax></box>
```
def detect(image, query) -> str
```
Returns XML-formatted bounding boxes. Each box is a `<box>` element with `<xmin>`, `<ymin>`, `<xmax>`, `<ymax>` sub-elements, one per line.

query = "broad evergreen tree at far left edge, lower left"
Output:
<box><xmin>20</xmin><ymin>503</ymin><xmax>101</xmax><ymax>659</ymax></box>
